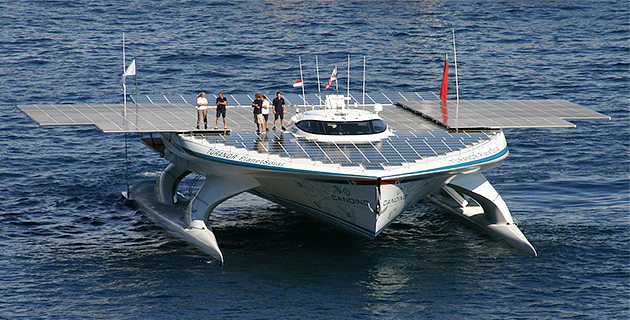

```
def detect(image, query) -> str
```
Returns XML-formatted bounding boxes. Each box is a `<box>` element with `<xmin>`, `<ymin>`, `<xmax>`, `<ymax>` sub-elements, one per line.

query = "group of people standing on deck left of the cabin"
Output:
<box><xmin>197</xmin><ymin>92</ymin><xmax>286</xmax><ymax>134</ymax></box>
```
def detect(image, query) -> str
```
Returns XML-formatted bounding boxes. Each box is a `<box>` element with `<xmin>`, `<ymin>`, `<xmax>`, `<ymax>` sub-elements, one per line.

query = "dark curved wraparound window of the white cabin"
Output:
<box><xmin>295</xmin><ymin>119</ymin><xmax>387</xmax><ymax>135</ymax></box>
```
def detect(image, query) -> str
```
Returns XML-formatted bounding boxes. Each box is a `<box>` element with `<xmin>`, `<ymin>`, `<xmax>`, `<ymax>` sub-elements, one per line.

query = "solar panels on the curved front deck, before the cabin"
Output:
<box><xmin>212</xmin><ymin>129</ymin><xmax>496</xmax><ymax>170</ymax></box>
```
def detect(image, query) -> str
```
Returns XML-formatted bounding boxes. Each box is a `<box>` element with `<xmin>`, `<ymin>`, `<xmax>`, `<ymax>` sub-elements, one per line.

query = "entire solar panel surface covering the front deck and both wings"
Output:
<box><xmin>18</xmin><ymin>93</ymin><xmax>610</xmax><ymax>170</ymax></box>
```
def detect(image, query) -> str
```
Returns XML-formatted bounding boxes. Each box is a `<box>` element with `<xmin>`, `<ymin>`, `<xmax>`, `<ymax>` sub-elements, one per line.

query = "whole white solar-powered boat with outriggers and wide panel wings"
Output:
<box><xmin>18</xmin><ymin>88</ymin><xmax>609</xmax><ymax>263</ymax></box>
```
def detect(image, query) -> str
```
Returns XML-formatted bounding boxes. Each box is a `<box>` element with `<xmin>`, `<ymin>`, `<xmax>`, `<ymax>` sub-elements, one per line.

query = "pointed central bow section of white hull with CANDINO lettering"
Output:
<box><xmin>250</xmin><ymin>176</ymin><xmax>448</xmax><ymax>239</ymax></box>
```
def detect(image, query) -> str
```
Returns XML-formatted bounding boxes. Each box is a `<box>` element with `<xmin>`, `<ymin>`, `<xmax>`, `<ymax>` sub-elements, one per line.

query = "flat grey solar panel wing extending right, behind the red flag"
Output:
<box><xmin>397</xmin><ymin>100</ymin><xmax>610</xmax><ymax>129</ymax></box>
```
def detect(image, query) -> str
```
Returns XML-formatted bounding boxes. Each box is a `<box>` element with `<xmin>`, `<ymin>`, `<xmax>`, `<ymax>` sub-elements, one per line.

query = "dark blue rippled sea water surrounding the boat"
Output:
<box><xmin>0</xmin><ymin>0</ymin><xmax>630</xmax><ymax>319</ymax></box>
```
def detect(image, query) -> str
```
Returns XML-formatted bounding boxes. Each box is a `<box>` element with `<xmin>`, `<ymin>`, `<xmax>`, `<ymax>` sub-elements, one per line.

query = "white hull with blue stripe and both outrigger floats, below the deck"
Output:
<box><xmin>132</xmin><ymin>130</ymin><xmax>536</xmax><ymax>263</ymax></box>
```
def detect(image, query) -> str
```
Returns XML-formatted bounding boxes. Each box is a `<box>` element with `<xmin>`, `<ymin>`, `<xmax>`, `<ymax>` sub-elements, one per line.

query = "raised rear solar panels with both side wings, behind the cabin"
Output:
<box><xmin>18</xmin><ymin>92</ymin><xmax>610</xmax><ymax>133</ymax></box>
